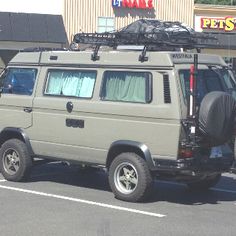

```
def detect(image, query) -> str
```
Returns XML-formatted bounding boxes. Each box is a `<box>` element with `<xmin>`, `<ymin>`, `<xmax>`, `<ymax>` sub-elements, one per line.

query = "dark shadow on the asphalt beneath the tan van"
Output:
<box><xmin>29</xmin><ymin>163</ymin><xmax>236</xmax><ymax>205</ymax></box>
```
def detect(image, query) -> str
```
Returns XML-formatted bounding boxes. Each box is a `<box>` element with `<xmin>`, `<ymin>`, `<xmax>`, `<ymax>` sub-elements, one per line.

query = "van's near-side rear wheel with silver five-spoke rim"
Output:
<box><xmin>109</xmin><ymin>153</ymin><xmax>153</xmax><ymax>202</ymax></box>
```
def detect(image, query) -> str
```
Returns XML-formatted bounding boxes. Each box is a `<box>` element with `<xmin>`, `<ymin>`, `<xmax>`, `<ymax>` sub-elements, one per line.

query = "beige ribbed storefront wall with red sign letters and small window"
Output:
<box><xmin>64</xmin><ymin>0</ymin><xmax>194</xmax><ymax>41</ymax></box>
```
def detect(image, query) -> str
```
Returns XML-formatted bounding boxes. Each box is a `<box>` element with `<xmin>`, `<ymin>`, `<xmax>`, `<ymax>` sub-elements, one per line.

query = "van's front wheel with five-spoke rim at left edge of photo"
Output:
<box><xmin>0</xmin><ymin>139</ymin><xmax>32</xmax><ymax>182</ymax></box>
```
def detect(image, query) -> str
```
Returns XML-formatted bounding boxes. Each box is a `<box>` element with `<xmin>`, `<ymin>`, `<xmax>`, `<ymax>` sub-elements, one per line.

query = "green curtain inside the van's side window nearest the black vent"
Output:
<box><xmin>105</xmin><ymin>72</ymin><xmax>146</xmax><ymax>102</ymax></box>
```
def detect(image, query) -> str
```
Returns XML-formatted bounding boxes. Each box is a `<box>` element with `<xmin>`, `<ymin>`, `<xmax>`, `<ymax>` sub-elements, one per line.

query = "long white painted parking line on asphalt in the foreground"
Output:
<box><xmin>0</xmin><ymin>181</ymin><xmax>166</xmax><ymax>218</ymax></box>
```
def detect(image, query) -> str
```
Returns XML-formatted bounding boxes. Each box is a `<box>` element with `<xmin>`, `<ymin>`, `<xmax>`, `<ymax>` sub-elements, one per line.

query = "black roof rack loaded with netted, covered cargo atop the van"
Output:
<box><xmin>71</xmin><ymin>19</ymin><xmax>217</xmax><ymax>61</ymax></box>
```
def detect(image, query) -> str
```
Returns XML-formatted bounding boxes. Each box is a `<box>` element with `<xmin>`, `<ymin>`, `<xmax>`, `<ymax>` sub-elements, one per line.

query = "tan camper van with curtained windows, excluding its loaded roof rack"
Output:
<box><xmin>0</xmin><ymin>20</ymin><xmax>236</xmax><ymax>201</ymax></box>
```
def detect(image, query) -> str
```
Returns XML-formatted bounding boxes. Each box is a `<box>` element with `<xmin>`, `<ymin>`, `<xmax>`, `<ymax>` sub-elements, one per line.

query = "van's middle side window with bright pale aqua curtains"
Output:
<box><xmin>44</xmin><ymin>70</ymin><xmax>96</xmax><ymax>98</ymax></box>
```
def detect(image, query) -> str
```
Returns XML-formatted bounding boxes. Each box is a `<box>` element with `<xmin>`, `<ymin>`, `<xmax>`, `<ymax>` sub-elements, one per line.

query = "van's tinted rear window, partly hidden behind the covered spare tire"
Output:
<box><xmin>179</xmin><ymin>66</ymin><xmax>236</xmax><ymax>104</ymax></box>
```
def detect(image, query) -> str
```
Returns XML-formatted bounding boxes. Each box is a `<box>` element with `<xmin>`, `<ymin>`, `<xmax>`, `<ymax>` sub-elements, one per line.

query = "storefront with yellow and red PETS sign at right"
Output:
<box><xmin>194</xmin><ymin>4</ymin><xmax>236</xmax><ymax>70</ymax></box>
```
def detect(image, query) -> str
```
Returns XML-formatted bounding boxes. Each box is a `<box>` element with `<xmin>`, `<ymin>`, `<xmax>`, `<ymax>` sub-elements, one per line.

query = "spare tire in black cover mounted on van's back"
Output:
<box><xmin>199</xmin><ymin>91</ymin><xmax>236</xmax><ymax>146</ymax></box>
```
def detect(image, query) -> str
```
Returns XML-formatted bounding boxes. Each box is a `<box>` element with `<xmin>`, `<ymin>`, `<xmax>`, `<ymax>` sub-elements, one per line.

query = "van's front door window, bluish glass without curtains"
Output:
<box><xmin>1</xmin><ymin>68</ymin><xmax>37</xmax><ymax>95</ymax></box>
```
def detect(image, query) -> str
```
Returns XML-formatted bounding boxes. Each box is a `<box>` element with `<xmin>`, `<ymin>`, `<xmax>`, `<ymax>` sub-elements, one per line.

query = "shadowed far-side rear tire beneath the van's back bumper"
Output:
<box><xmin>187</xmin><ymin>174</ymin><xmax>221</xmax><ymax>191</ymax></box>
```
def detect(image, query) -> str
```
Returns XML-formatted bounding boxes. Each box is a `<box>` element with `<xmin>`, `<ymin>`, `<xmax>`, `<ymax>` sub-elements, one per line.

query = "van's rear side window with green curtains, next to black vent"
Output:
<box><xmin>100</xmin><ymin>71</ymin><xmax>152</xmax><ymax>103</ymax></box>
